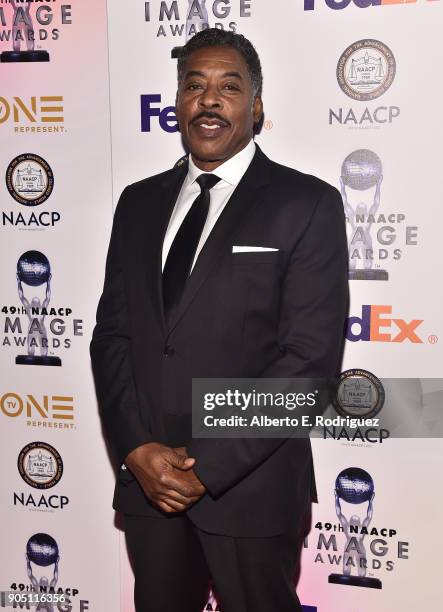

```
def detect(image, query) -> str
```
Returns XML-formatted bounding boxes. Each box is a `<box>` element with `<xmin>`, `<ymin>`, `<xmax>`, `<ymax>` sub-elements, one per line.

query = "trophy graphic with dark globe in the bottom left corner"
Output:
<box><xmin>26</xmin><ymin>533</ymin><xmax>60</xmax><ymax>612</ymax></box>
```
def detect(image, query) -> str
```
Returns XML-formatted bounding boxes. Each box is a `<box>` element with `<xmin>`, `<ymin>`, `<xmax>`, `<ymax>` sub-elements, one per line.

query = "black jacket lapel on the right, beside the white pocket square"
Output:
<box><xmin>166</xmin><ymin>146</ymin><xmax>270</xmax><ymax>331</ymax></box>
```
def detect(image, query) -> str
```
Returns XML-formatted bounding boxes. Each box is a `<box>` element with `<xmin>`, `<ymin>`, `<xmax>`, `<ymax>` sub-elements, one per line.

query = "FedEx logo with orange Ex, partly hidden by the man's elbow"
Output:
<box><xmin>346</xmin><ymin>305</ymin><xmax>423</xmax><ymax>344</ymax></box>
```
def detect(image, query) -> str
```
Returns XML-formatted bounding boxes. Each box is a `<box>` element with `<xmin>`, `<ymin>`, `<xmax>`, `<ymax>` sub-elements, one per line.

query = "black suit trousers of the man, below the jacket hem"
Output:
<box><xmin>124</xmin><ymin>508</ymin><xmax>302</xmax><ymax>612</ymax></box>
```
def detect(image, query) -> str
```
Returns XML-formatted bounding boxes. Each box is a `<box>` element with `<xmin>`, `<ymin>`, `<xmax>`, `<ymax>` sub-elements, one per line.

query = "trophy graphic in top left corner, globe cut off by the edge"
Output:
<box><xmin>0</xmin><ymin>0</ymin><xmax>49</xmax><ymax>62</ymax></box>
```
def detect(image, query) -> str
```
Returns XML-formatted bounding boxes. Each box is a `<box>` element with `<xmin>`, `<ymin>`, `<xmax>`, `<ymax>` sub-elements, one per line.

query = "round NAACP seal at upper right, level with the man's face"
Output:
<box><xmin>337</xmin><ymin>38</ymin><xmax>396</xmax><ymax>100</ymax></box>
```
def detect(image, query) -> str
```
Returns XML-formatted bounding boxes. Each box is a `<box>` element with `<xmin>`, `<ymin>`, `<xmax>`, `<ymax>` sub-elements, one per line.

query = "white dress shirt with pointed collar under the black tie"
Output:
<box><xmin>162</xmin><ymin>139</ymin><xmax>255</xmax><ymax>270</ymax></box>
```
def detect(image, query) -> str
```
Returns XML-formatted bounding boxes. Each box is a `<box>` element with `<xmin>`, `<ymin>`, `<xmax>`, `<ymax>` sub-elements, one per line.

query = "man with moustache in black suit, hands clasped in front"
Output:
<box><xmin>91</xmin><ymin>29</ymin><xmax>347</xmax><ymax>612</ymax></box>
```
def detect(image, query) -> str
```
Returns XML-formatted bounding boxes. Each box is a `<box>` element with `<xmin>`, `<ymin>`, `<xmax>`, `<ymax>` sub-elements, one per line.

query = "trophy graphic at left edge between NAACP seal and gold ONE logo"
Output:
<box><xmin>15</xmin><ymin>251</ymin><xmax>62</xmax><ymax>366</ymax></box>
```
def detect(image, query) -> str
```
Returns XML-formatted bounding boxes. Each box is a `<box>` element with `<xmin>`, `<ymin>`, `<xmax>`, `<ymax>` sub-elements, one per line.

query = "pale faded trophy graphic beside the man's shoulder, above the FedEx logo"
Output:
<box><xmin>340</xmin><ymin>149</ymin><xmax>389</xmax><ymax>280</ymax></box>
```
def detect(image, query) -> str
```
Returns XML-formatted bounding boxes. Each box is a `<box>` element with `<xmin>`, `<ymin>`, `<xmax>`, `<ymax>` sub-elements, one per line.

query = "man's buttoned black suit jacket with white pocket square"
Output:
<box><xmin>91</xmin><ymin>147</ymin><xmax>348</xmax><ymax>536</ymax></box>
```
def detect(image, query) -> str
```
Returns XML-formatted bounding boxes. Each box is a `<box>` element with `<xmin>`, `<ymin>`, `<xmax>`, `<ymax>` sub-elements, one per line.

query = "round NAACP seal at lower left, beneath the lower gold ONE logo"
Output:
<box><xmin>17</xmin><ymin>442</ymin><xmax>63</xmax><ymax>489</ymax></box>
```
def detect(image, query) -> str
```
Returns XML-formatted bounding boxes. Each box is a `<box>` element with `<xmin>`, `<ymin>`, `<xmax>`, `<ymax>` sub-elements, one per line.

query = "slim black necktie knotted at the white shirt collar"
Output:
<box><xmin>163</xmin><ymin>174</ymin><xmax>220</xmax><ymax>318</ymax></box>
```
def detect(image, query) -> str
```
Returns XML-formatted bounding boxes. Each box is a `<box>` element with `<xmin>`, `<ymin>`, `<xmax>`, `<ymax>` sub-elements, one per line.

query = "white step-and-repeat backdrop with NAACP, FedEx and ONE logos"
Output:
<box><xmin>0</xmin><ymin>0</ymin><xmax>443</xmax><ymax>612</ymax></box>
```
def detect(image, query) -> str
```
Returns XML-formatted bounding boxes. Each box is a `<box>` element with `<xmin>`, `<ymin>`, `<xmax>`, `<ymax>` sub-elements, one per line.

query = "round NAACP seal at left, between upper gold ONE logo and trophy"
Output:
<box><xmin>6</xmin><ymin>153</ymin><xmax>54</xmax><ymax>206</ymax></box>
